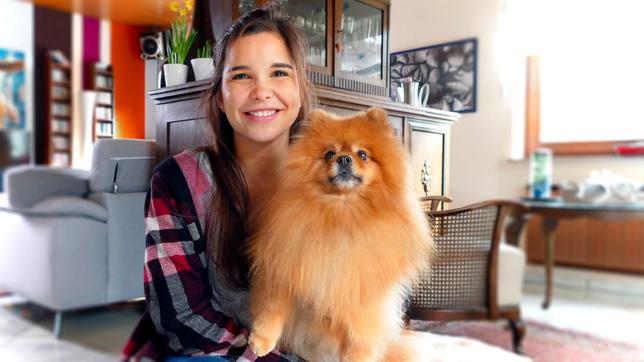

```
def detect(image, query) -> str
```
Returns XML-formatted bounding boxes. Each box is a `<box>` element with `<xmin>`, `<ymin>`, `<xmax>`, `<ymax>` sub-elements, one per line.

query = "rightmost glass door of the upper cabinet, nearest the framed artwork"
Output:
<box><xmin>339</xmin><ymin>0</ymin><xmax>384</xmax><ymax>80</ymax></box>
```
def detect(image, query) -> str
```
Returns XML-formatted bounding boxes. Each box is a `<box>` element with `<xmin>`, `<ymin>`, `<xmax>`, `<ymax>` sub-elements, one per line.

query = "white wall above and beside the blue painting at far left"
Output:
<box><xmin>0</xmin><ymin>0</ymin><xmax>34</xmax><ymax>130</ymax></box>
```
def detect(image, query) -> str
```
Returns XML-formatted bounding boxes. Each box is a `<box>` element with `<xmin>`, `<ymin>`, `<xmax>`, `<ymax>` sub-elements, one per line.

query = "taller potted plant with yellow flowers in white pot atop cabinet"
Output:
<box><xmin>163</xmin><ymin>0</ymin><xmax>197</xmax><ymax>87</ymax></box>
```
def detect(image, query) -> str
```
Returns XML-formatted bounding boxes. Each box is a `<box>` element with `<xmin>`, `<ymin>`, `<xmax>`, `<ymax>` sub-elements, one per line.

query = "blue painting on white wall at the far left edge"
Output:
<box><xmin>0</xmin><ymin>49</ymin><xmax>27</xmax><ymax>130</ymax></box>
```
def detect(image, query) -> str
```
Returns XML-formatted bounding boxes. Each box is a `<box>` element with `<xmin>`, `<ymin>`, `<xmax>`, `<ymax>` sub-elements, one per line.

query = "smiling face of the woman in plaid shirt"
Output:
<box><xmin>220</xmin><ymin>32</ymin><xmax>301</xmax><ymax>148</ymax></box>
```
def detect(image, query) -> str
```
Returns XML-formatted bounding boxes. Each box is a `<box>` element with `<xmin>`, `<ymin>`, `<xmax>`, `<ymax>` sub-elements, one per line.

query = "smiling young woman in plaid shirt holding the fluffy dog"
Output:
<box><xmin>123</xmin><ymin>6</ymin><xmax>311</xmax><ymax>361</ymax></box>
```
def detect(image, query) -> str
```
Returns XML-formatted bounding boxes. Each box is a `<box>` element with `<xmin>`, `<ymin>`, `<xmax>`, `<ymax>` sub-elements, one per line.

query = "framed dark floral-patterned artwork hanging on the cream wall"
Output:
<box><xmin>389</xmin><ymin>38</ymin><xmax>478</xmax><ymax>113</ymax></box>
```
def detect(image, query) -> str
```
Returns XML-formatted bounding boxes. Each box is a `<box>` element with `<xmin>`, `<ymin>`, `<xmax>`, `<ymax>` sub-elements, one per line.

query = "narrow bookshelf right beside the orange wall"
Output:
<box><xmin>92</xmin><ymin>63</ymin><xmax>115</xmax><ymax>142</ymax></box>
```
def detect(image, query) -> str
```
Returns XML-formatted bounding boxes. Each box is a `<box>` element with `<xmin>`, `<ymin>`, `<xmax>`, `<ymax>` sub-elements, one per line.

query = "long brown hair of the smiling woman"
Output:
<box><xmin>206</xmin><ymin>4</ymin><xmax>314</xmax><ymax>288</ymax></box>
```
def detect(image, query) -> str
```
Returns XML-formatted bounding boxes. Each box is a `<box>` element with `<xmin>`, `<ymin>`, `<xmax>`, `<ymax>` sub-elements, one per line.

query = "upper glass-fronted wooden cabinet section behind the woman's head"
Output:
<box><xmin>193</xmin><ymin>0</ymin><xmax>390</xmax><ymax>97</ymax></box>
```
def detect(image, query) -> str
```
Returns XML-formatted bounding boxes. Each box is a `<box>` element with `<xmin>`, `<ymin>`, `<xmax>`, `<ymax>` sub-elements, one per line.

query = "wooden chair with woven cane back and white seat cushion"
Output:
<box><xmin>407</xmin><ymin>200</ymin><xmax>525</xmax><ymax>353</ymax></box>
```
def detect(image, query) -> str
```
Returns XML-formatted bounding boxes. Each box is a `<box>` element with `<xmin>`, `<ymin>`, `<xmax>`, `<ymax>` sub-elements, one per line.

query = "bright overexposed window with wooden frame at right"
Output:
<box><xmin>513</xmin><ymin>0</ymin><xmax>644</xmax><ymax>155</ymax></box>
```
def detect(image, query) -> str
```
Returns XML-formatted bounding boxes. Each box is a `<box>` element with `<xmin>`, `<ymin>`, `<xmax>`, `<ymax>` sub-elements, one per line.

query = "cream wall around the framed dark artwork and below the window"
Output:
<box><xmin>389</xmin><ymin>0</ymin><xmax>644</xmax><ymax>206</ymax></box>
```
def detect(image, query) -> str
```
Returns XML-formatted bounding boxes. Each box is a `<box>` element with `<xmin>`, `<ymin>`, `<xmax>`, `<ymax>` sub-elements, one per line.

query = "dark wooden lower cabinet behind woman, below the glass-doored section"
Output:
<box><xmin>150</xmin><ymin>80</ymin><xmax>460</xmax><ymax>197</ymax></box>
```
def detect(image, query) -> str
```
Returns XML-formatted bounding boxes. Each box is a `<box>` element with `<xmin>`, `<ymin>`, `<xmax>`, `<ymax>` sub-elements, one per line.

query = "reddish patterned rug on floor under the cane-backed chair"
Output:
<box><xmin>412</xmin><ymin>321</ymin><xmax>644</xmax><ymax>362</ymax></box>
